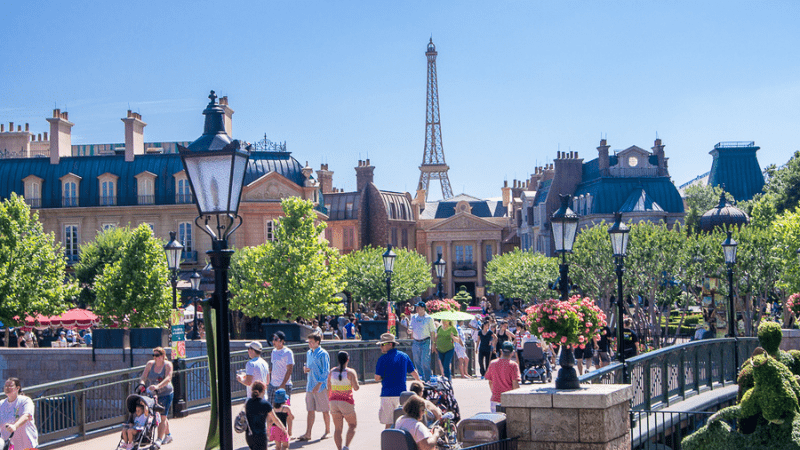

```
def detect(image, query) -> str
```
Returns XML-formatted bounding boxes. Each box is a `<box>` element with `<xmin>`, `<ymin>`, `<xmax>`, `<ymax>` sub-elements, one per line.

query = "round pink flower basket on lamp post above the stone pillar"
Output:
<box><xmin>523</xmin><ymin>295</ymin><xmax>606</xmax><ymax>348</ymax></box>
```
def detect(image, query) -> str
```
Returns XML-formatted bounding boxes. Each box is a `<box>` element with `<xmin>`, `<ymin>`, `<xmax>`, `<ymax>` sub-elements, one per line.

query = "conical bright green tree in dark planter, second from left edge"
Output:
<box><xmin>94</xmin><ymin>224</ymin><xmax>172</xmax><ymax>328</ymax></box>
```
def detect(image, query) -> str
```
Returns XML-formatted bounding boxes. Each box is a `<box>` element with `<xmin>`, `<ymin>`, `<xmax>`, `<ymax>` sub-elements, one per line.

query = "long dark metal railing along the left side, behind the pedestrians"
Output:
<box><xmin>12</xmin><ymin>340</ymin><xmax>474</xmax><ymax>446</ymax></box>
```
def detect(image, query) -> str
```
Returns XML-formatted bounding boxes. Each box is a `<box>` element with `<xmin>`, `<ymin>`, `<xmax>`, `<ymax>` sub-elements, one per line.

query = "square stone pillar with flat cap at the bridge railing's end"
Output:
<box><xmin>501</xmin><ymin>384</ymin><xmax>633</xmax><ymax>450</ymax></box>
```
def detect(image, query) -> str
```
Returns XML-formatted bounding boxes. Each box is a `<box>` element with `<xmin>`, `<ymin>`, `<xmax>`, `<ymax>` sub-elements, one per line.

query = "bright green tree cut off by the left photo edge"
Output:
<box><xmin>0</xmin><ymin>193</ymin><xmax>78</xmax><ymax>326</ymax></box>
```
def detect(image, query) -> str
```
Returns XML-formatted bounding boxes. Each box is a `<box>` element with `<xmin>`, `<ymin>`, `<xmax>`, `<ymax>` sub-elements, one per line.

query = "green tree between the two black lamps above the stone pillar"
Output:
<box><xmin>567</xmin><ymin>222</ymin><xmax>617</xmax><ymax>312</ymax></box>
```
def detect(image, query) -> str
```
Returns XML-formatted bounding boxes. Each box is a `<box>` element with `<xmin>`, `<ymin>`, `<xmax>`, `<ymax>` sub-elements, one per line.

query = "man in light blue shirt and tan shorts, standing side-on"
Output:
<box><xmin>297</xmin><ymin>332</ymin><xmax>331</xmax><ymax>441</ymax></box>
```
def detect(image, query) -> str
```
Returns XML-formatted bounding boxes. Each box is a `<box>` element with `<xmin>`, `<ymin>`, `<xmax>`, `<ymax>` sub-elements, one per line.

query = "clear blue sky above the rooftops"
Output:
<box><xmin>0</xmin><ymin>0</ymin><xmax>800</xmax><ymax>199</ymax></box>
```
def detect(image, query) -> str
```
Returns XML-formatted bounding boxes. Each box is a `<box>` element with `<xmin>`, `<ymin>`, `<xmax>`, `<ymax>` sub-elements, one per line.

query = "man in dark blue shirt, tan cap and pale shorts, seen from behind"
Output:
<box><xmin>375</xmin><ymin>333</ymin><xmax>421</xmax><ymax>429</ymax></box>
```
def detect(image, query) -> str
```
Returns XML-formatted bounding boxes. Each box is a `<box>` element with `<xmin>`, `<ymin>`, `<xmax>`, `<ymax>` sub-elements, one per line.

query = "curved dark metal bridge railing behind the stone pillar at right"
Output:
<box><xmin>580</xmin><ymin>338</ymin><xmax>758</xmax><ymax>411</ymax></box>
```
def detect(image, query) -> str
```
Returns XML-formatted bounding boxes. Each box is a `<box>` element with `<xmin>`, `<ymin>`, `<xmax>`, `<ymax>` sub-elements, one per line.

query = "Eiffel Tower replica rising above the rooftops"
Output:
<box><xmin>419</xmin><ymin>38</ymin><xmax>453</xmax><ymax>200</ymax></box>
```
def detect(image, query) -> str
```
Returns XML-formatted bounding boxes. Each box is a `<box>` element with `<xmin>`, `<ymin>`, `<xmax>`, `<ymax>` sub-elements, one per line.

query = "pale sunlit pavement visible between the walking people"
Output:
<box><xmin>51</xmin><ymin>378</ymin><xmax>491</xmax><ymax>450</ymax></box>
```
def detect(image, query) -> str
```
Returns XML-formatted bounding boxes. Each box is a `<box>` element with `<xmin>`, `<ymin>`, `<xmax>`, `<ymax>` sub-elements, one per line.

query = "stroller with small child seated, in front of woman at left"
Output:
<box><xmin>117</xmin><ymin>394</ymin><xmax>164</xmax><ymax>450</ymax></box>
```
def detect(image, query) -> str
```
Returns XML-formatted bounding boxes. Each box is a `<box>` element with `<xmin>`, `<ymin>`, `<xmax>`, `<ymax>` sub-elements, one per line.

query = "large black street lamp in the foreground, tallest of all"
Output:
<box><xmin>178</xmin><ymin>91</ymin><xmax>250</xmax><ymax>450</ymax></box>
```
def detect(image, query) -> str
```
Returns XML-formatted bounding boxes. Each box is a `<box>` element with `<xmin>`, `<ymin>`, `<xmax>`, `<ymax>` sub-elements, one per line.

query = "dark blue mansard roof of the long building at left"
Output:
<box><xmin>0</xmin><ymin>151</ymin><xmax>305</xmax><ymax>208</ymax></box>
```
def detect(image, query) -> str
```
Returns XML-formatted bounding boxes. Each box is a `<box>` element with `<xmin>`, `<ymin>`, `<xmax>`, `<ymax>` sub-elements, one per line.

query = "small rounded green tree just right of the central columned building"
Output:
<box><xmin>486</xmin><ymin>248</ymin><xmax>558</xmax><ymax>302</ymax></box>
